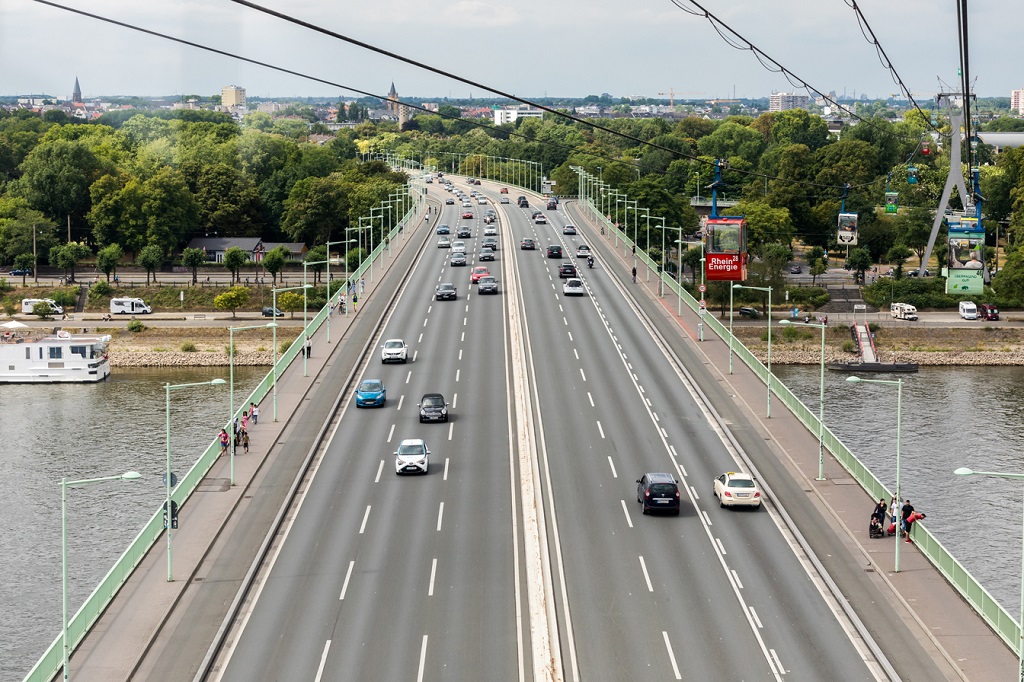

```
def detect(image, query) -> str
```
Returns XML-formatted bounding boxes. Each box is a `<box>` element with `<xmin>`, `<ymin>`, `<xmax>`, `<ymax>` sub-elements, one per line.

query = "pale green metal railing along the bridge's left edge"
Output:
<box><xmin>25</xmin><ymin>191</ymin><xmax>419</xmax><ymax>682</ymax></box>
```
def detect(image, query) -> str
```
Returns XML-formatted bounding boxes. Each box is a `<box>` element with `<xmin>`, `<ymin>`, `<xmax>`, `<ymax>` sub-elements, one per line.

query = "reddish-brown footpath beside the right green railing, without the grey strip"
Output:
<box><xmin>573</xmin><ymin>199</ymin><xmax>1018</xmax><ymax>680</ymax></box>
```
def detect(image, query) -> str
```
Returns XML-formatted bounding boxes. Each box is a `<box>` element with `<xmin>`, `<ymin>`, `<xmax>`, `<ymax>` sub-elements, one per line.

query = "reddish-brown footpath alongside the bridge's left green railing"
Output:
<box><xmin>71</xmin><ymin>198</ymin><xmax>437</xmax><ymax>682</ymax></box>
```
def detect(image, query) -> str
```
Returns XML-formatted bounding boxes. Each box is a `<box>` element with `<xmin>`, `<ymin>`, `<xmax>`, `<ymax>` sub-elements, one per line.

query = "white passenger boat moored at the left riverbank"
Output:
<box><xmin>0</xmin><ymin>324</ymin><xmax>111</xmax><ymax>384</ymax></box>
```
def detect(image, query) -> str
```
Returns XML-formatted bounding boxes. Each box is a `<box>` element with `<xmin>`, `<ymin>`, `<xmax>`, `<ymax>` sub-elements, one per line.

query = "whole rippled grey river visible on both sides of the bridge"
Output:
<box><xmin>0</xmin><ymin>366</ymin><xmax>1024</xmax><ymax>680</ymax></box>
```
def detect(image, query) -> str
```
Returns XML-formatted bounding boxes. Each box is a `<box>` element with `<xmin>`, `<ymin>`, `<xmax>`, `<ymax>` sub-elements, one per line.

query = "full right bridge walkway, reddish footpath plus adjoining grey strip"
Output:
<box><xmin>565</xmin><ymin>197</ymin><xmax>1018</xmax><ymax>681</ymax></box>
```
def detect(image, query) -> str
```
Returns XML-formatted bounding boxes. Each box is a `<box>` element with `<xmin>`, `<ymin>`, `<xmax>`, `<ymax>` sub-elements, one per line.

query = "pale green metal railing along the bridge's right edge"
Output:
<box><xmin>583</xmin><ymin>199</ymin><xmax>1021</xmax><ymax>651</ymax></box>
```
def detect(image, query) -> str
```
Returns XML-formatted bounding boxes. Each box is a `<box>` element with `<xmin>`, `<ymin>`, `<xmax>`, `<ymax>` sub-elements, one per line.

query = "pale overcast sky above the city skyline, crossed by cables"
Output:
<box><xmin>0</xmin><ymin>0</ymin><xmax>1024</xmax><ymax>99</ymax></box>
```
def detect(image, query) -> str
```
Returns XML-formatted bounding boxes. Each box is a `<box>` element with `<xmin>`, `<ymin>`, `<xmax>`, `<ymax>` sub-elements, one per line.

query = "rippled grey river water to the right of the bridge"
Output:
<box><xmin>772</xmin><ymin>366</ymin><xmax>1024</xmax><ymax>619</ymax></box>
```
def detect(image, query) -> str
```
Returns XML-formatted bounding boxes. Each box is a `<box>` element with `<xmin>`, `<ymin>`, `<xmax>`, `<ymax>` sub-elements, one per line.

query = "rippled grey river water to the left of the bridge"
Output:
<box><xmin>0</xmin><ymin>368</ymin><xmax>268</xmax><ymax>680</ymax></box>
